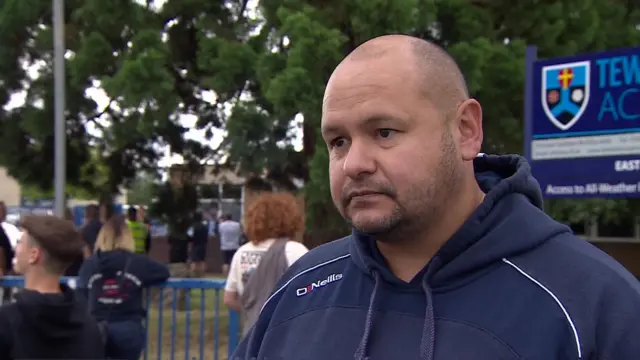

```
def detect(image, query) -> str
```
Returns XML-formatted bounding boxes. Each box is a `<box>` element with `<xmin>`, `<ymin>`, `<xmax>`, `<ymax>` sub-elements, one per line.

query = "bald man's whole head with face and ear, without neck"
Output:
<box><xmin>321</xmin><ymin>35</ymin><xmax>482</xmax><ymax>244</ymax></box>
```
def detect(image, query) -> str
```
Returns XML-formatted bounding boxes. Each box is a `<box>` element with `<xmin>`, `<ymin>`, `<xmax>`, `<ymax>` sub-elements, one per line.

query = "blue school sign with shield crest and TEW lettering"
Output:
<box><xmin>525</xmin><ymin>47</ymin><xmax>640</xmax><ymax>197</ymax></box>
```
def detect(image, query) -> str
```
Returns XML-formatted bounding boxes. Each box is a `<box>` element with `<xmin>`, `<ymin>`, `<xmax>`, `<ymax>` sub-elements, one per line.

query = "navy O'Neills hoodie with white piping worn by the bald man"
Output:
<box><xmin>232</xmin><ymin>156</ymin><xmax>640</xmax><ymax>360</ymax></box>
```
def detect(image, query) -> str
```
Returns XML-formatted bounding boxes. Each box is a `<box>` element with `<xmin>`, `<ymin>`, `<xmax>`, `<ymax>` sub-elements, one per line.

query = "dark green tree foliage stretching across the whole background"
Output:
<box><xmin>0</xmin><ymin>0</ymin><xmax>640</xmax><ymax>239</ymax></box>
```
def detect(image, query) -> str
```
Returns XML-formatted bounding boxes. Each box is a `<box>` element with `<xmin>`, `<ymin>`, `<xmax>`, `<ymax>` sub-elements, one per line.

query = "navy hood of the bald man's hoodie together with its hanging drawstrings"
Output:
<box><xmin>350</xmin><ymin>155</ymin><xmax>569</xmax><ymax>360</ymax></box>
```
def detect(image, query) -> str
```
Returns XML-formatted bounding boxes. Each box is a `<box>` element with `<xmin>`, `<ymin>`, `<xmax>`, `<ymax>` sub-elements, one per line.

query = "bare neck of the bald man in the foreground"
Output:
<box><xmin>377</xmin><ymin>177</ymin><xmax>484</xmax><ymax>282</ymax></box>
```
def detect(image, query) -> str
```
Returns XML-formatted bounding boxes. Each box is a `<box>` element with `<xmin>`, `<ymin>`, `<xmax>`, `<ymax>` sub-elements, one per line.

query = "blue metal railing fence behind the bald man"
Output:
<box><xmin>0</xmin><ymin>276</ymin><xmax>240</xmax><ymax>360</ymax></box>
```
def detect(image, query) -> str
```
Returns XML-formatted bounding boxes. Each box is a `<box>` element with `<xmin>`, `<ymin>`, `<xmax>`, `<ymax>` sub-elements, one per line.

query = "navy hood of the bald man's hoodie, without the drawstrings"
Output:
<box><xmin>351</xmin><ymin>155</ymin><xmax>568</xmax><ymax>290</ymax></box>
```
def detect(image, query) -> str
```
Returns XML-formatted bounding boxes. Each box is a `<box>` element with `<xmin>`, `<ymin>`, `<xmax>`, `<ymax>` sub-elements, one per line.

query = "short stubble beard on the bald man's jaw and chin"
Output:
<box><xmin>347</xmin><ymin>132</ymin><xmax>460</xmax><ymax>242</ymax></box>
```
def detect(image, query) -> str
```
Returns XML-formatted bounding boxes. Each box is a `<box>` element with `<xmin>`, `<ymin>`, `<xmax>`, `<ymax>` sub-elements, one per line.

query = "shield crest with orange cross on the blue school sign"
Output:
<box><xmin>541</xmin><ymin>61</ymin><xmax>590</xmax><ymax>130</ymax></box>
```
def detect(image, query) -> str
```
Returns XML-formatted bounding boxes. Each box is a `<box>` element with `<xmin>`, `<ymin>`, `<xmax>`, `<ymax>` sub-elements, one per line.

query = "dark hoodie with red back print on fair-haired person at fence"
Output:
<box><xmin>77</xmin><ymin>250</ymin><xmax>169</xmax><ymax>322</ymax></box>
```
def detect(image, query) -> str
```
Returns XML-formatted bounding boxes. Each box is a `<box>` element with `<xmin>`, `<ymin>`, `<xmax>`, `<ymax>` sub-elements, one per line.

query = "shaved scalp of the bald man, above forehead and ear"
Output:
<box><xmin>332</xmin><ymin>35</ymin><xmax>469</xmax><ymax>116</ymax></box>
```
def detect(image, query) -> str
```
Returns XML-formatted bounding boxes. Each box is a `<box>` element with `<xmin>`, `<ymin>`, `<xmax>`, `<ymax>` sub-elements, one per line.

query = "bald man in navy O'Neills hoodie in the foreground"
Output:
<box><xmin>233</xmin><ymin>36</ymin><xmax>640</xmax><ymax>360</ymax></box>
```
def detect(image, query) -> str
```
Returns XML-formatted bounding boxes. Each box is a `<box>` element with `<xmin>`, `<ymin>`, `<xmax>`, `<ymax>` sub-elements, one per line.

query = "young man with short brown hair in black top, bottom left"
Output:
<box><xmin>0</xmin><ymin>216</ymin><xmax>104</xmax><ymax>360</ymax></box>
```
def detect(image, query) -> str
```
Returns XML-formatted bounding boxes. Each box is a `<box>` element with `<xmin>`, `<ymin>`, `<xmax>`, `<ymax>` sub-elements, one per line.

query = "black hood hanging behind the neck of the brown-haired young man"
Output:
<box><xmin>16</xmin><ymin>285</ymin><xmax>87</xmax><ymax>341</ymax></box>
